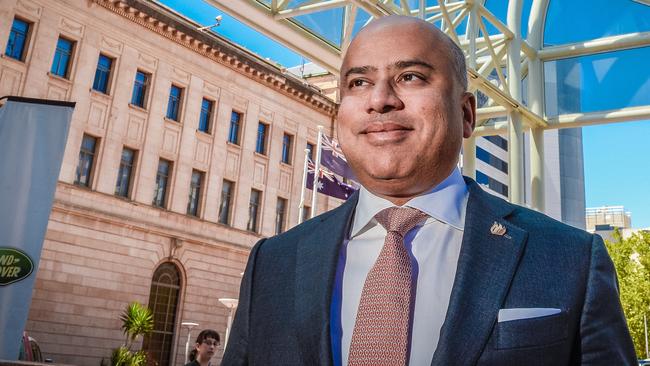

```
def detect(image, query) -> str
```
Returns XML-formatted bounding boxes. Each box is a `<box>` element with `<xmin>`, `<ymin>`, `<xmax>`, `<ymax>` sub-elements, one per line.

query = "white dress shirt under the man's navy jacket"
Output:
<box><xmin>341</xmin><ymin>168</ymin><xmax>468</xmax><ymax>366</ymax></box>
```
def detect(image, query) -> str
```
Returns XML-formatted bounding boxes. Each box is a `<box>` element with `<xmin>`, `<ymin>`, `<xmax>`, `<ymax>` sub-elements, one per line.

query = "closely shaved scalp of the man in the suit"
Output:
<box><xmin>341</xmin><ymin>15</ymin><xmax>467</xmax><ymax>90</ymax></box>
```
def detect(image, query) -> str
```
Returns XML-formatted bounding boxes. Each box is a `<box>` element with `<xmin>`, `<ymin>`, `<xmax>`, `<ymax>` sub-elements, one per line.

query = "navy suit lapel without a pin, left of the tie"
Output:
<box><xmin>295</xmin><ymin>193</ymin><xmax>358</xmax><ymax>365</ymax></box>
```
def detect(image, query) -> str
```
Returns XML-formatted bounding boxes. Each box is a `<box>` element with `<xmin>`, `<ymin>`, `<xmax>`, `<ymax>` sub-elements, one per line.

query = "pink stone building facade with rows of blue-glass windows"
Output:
<box><xmin>0</xmin><ymin>0</ymin><xmax>340</xmax><ymax>366</ymax></box>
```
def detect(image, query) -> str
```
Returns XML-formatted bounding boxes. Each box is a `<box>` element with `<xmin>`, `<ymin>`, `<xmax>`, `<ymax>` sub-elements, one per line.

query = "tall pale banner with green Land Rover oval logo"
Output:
<box><xmin>0</xmin><ymin>97</ymin><xmax>74</xmax><ymax>360</ymax></box>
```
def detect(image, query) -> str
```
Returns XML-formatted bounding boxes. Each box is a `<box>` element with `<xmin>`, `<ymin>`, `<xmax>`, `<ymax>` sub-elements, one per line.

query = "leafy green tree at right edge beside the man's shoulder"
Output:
<box><xmin>603</xmin><ymin>231</ymin><xmax>650</xmax><ymax>358</ymax></box>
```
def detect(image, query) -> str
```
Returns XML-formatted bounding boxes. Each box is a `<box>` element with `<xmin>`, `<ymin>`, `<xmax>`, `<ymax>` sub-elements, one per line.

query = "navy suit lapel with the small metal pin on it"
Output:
<box><xmin>431</xmin><ymin>180</ymin><xmax>527</xmax><ymax>366</ymax></box>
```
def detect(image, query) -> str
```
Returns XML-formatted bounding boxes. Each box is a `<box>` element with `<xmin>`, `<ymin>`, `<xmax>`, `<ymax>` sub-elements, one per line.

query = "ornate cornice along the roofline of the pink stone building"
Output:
<box><xmin>92</xmin><ymin>0</ymin><xmax>337</xmax><ymax>117</ymax></box>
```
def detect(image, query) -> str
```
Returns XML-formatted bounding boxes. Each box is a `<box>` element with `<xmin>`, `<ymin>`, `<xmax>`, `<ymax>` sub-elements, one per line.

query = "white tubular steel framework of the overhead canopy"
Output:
<box><xmin>206</xmin><ymin>0</ymin><xmax>650</xmax><ymax>211</ymax></box>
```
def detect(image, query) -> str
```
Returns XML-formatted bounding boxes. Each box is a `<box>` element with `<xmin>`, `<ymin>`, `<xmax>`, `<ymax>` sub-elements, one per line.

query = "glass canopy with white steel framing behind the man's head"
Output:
<box><xmin>159</xmin><ymin>0</ymin><xmax>650</xmax><ymax>210</ymax></box>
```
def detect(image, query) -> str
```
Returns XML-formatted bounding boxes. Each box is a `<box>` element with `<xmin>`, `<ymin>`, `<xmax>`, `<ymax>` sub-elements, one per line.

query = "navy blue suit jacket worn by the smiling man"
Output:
<box><xmin>222</xmin><ymin>178</ymin><xmax>636</xmax><ymax>366</ymax></box>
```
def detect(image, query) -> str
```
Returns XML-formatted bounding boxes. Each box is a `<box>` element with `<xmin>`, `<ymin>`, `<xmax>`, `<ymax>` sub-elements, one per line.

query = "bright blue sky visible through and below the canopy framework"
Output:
<box><xmin>159</xmin><ymin>0</ymin><xmax>650</xmax><ymax>228</ymax></box>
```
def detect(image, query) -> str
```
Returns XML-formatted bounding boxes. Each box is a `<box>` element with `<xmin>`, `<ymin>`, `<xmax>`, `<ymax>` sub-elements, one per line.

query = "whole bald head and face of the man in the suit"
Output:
<box><xmin>337</xmin><ymin>16</ymin><xmax>476</xmax><ymax>205</ymax></box>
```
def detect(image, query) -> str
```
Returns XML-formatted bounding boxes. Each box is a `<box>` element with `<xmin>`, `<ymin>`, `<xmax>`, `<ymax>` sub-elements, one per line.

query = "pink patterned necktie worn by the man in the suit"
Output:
<box><xmin>348</xmin><ymin>207</ymin><xmax>428</xmax><ymax>366</ymax></box>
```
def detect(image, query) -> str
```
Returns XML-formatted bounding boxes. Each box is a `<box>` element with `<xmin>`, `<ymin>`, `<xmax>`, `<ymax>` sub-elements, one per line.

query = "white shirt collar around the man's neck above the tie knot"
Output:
<box><xmin>350</xmin><ymin>168</ymin><xmax>468</xmax><ymax>238</ymax></box>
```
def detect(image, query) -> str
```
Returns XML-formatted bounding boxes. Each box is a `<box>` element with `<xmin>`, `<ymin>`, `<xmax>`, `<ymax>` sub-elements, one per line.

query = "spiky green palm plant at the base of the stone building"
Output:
<box><xmin>111</xmin><ymin>302</ymin><xmax>153</xmax><ymax>366</ymax></box>
